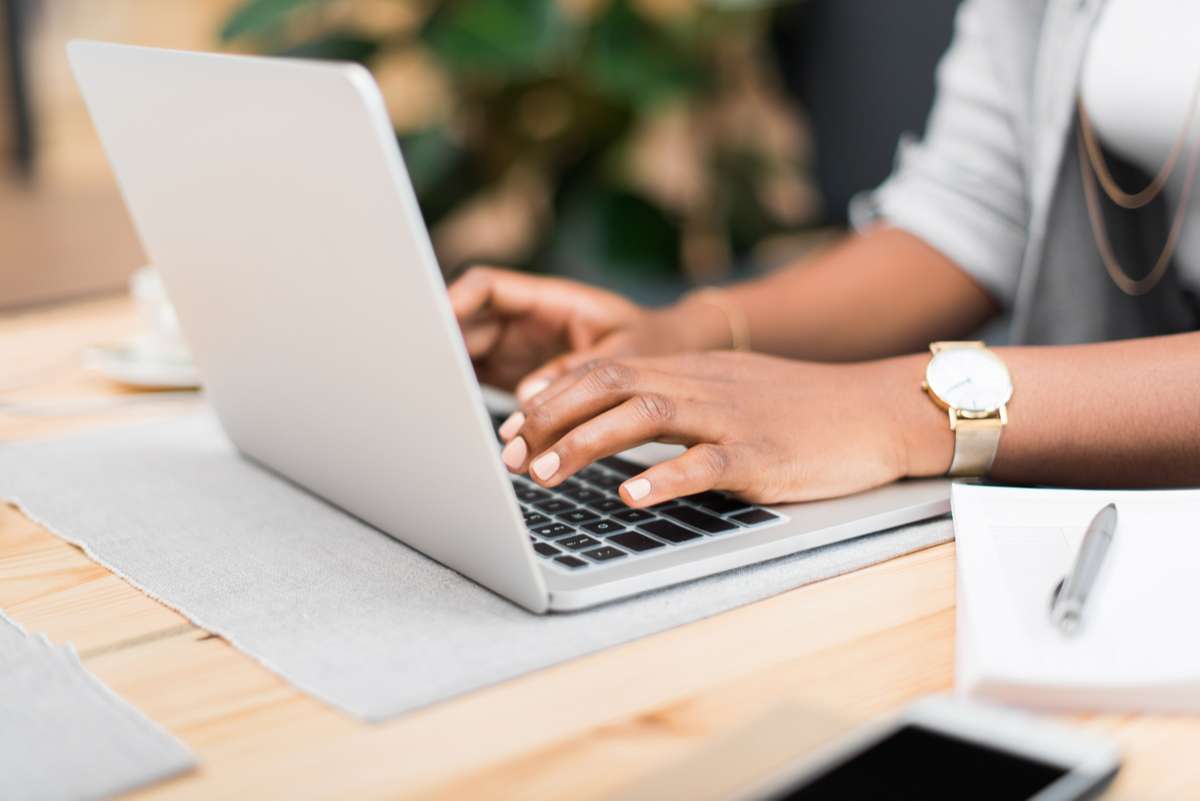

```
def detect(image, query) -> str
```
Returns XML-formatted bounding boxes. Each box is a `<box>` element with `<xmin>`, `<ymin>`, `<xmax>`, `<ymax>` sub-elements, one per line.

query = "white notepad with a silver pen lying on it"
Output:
<box><xmin>952</xmin><ymin>484</ymin><xmax>1200</xmax><ymax>712</ymax></box>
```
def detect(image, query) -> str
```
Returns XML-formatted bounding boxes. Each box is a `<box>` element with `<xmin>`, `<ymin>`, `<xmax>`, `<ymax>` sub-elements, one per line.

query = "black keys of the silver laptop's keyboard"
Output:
<box><xmin>493</xmin><ymin>416</ymin><xmax>785</xmax><ymax>572</ymax></box>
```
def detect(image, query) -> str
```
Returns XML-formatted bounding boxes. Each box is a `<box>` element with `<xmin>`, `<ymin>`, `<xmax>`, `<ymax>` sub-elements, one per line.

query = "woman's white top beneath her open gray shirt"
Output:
<box><xmin>1082</xmin><ymin>0</ymin><xmax>1200</xmax><ymax>287</ymax></box>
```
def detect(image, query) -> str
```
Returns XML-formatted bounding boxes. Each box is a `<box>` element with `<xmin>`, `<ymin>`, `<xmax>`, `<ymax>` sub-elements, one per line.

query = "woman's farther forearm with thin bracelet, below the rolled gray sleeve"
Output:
<box><xmin>689</xmin><ymin>227</ymin><xmax>996</xmax><ymax>361</ymax></box>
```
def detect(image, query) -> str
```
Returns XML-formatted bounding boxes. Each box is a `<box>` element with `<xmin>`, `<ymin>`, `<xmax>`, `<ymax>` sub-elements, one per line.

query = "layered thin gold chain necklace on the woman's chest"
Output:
<box><xmin>1075</xmin><ymin>80</ymin><xmax>1200</xmax><ymax>295</ymax></box>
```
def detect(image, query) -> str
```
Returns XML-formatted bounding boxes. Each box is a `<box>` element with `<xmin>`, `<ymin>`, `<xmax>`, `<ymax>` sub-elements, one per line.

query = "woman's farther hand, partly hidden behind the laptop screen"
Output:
<box><xmin>450</xmin><ymin>267</ymin><xmax>728</xmax><ymax>401</ymax></box>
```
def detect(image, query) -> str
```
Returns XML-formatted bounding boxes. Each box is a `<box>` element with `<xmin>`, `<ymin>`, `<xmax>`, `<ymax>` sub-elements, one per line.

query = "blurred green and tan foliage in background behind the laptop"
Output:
<box><xmin>221</xmin><ymin>0</ymin><xmax>812</xmax><ymax>279</ymax></box>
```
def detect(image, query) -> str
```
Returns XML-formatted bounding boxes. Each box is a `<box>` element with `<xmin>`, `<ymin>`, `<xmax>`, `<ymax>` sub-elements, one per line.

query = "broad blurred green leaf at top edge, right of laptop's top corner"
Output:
<box><xmin>422</xmin><ymin>0</ymin><xmax>575</xmax><ymax>79</ymax></box>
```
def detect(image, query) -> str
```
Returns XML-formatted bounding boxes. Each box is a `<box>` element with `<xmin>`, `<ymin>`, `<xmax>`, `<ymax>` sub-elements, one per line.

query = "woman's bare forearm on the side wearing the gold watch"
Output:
<box><xmin>892</xmin><ymin>333</ymin><xmax>1200</xmax><ymax>487</ymax></box>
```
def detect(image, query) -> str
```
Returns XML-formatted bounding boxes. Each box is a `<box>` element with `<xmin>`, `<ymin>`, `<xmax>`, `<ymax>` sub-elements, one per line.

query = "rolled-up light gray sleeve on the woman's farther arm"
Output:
<box><xmin>851</xmin><ymin>0</ymin><xmax>1028</xmax><ymax>308</ymax></box>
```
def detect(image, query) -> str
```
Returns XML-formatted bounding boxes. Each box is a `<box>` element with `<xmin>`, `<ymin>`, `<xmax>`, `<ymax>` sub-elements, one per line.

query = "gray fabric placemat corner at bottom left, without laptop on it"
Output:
<box><xmin>0</xmin><ymin>613</ymin><xmax>196</xmax><ymax>801</ymax></box>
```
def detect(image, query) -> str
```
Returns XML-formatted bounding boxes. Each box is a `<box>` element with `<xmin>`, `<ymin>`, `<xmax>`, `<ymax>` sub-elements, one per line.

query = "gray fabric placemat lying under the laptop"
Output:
<box><xmin>0</xmin><ymin>415</ymin><xmax>953</xmax><ymax>721</ymax></box>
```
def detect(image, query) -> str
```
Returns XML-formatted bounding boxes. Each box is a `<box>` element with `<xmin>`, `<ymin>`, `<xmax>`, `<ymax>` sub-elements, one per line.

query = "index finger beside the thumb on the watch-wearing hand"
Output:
<box><xmin>518</xmin><ymin>393</ymin><xmax>695</xmax><ymax>487</ymax></box>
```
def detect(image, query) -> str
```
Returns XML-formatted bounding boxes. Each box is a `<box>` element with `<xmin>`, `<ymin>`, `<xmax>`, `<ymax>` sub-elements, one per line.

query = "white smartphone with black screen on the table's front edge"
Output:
<box><xmin>739</xmin><ymin>697</ymin><xmax>1121</xmax><ymax>801</ymax></box>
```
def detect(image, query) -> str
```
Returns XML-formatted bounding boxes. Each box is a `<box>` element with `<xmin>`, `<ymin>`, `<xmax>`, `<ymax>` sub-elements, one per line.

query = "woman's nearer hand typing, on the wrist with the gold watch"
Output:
<box><xmin>500</xmin><ymin>353</ymin><xmax>953</xmax><ymax>507</ymax></box>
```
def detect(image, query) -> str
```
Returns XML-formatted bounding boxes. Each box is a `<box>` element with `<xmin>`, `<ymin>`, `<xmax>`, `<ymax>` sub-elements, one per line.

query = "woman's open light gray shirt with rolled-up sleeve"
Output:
<box><xmin>852</xmin><ymin>0</ymin><xmax>1200</xmax><ymax>344</ymax></box>
